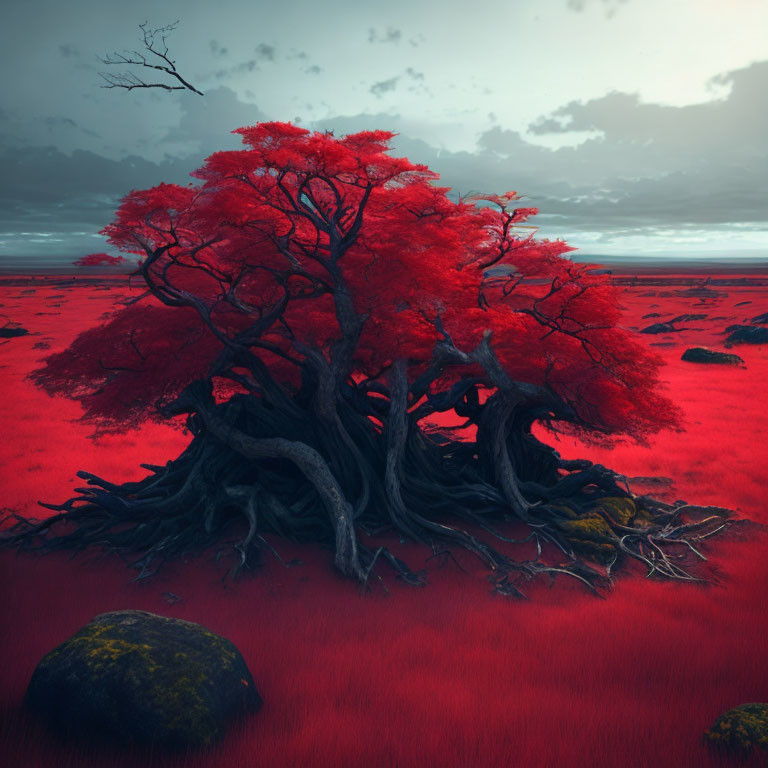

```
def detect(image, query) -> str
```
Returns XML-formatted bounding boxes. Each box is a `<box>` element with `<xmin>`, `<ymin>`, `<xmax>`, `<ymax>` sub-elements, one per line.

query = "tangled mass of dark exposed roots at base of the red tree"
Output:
<box><xmin>2</xmin><ymin>380</ymin><xmax>732</xmax><ymax>597</ymax></box>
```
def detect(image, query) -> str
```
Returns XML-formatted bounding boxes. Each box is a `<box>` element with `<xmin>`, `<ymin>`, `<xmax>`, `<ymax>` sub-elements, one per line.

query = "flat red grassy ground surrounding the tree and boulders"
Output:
<box><xmin>0</xmin><ymin>275</ymin><xmax>768</xmax><ymax>768</ymax></box>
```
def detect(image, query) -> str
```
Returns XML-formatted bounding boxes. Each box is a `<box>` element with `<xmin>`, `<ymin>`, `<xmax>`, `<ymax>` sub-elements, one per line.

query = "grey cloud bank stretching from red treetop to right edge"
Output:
<box><xmin>322</xmin><ymin>62</ymin><xmax>768</xmax><ymax>235</ymax></box>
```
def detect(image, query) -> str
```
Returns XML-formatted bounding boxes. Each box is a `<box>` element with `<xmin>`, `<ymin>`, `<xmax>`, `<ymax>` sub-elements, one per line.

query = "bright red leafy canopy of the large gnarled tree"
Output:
<box><xmin>38</xmin><ymin>123</ymin><xmax>676</xmax><ymax>439</ymax></box>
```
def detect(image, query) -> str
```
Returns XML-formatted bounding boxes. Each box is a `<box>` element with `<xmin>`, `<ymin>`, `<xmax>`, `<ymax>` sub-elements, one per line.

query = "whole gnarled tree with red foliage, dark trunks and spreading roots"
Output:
<box><xmin>9</xmin><ymin>122</ymin><xmax>727</xmax><ymax>594</ymax></box>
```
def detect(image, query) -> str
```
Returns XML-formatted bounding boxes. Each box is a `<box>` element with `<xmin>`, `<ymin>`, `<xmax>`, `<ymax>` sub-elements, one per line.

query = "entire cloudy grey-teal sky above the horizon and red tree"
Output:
<box><xmin>0</xmin><ymin>0</ymin><xmax>768</xmax><ymax>268</ymax></box>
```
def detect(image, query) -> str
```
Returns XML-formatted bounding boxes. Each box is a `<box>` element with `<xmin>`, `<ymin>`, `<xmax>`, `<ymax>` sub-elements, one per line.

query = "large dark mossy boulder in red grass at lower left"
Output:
<box><xmin>27</xmin><ymin>611</ymin><xmax>261</xmax><ymax>749</ymax></box>
